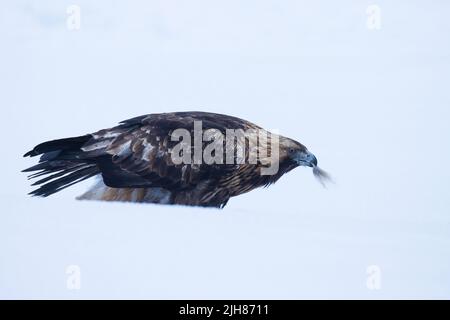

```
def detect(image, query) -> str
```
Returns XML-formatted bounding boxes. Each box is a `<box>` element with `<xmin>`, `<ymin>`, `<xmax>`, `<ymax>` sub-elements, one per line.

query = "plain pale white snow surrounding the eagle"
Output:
<box><xmin>0</xmin><ymin>0</ymin><xmax>450</xmax><ymax>299</ymax></box>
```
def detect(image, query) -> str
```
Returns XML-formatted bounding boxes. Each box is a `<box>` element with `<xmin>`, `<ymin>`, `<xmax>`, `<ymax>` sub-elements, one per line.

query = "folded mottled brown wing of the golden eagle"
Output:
<box><xmin>82</xmin><ymin>112</ymin><xmax>260</xmax><ymax>190</ymax></box>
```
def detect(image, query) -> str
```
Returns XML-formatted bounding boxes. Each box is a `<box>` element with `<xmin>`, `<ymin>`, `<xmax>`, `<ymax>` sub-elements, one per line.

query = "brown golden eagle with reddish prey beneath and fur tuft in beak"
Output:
<box><xmin>24</xmin><ymin>112</ymin><xmax>328</xmax><ymax>208</ymax></box>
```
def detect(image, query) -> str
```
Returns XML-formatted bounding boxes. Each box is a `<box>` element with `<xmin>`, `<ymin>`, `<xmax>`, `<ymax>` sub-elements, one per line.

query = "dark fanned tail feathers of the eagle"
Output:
<box><xmin>23</xmin><ymin>135</ymin><xmax>100</xmax><ymax>197</ymax></box>
